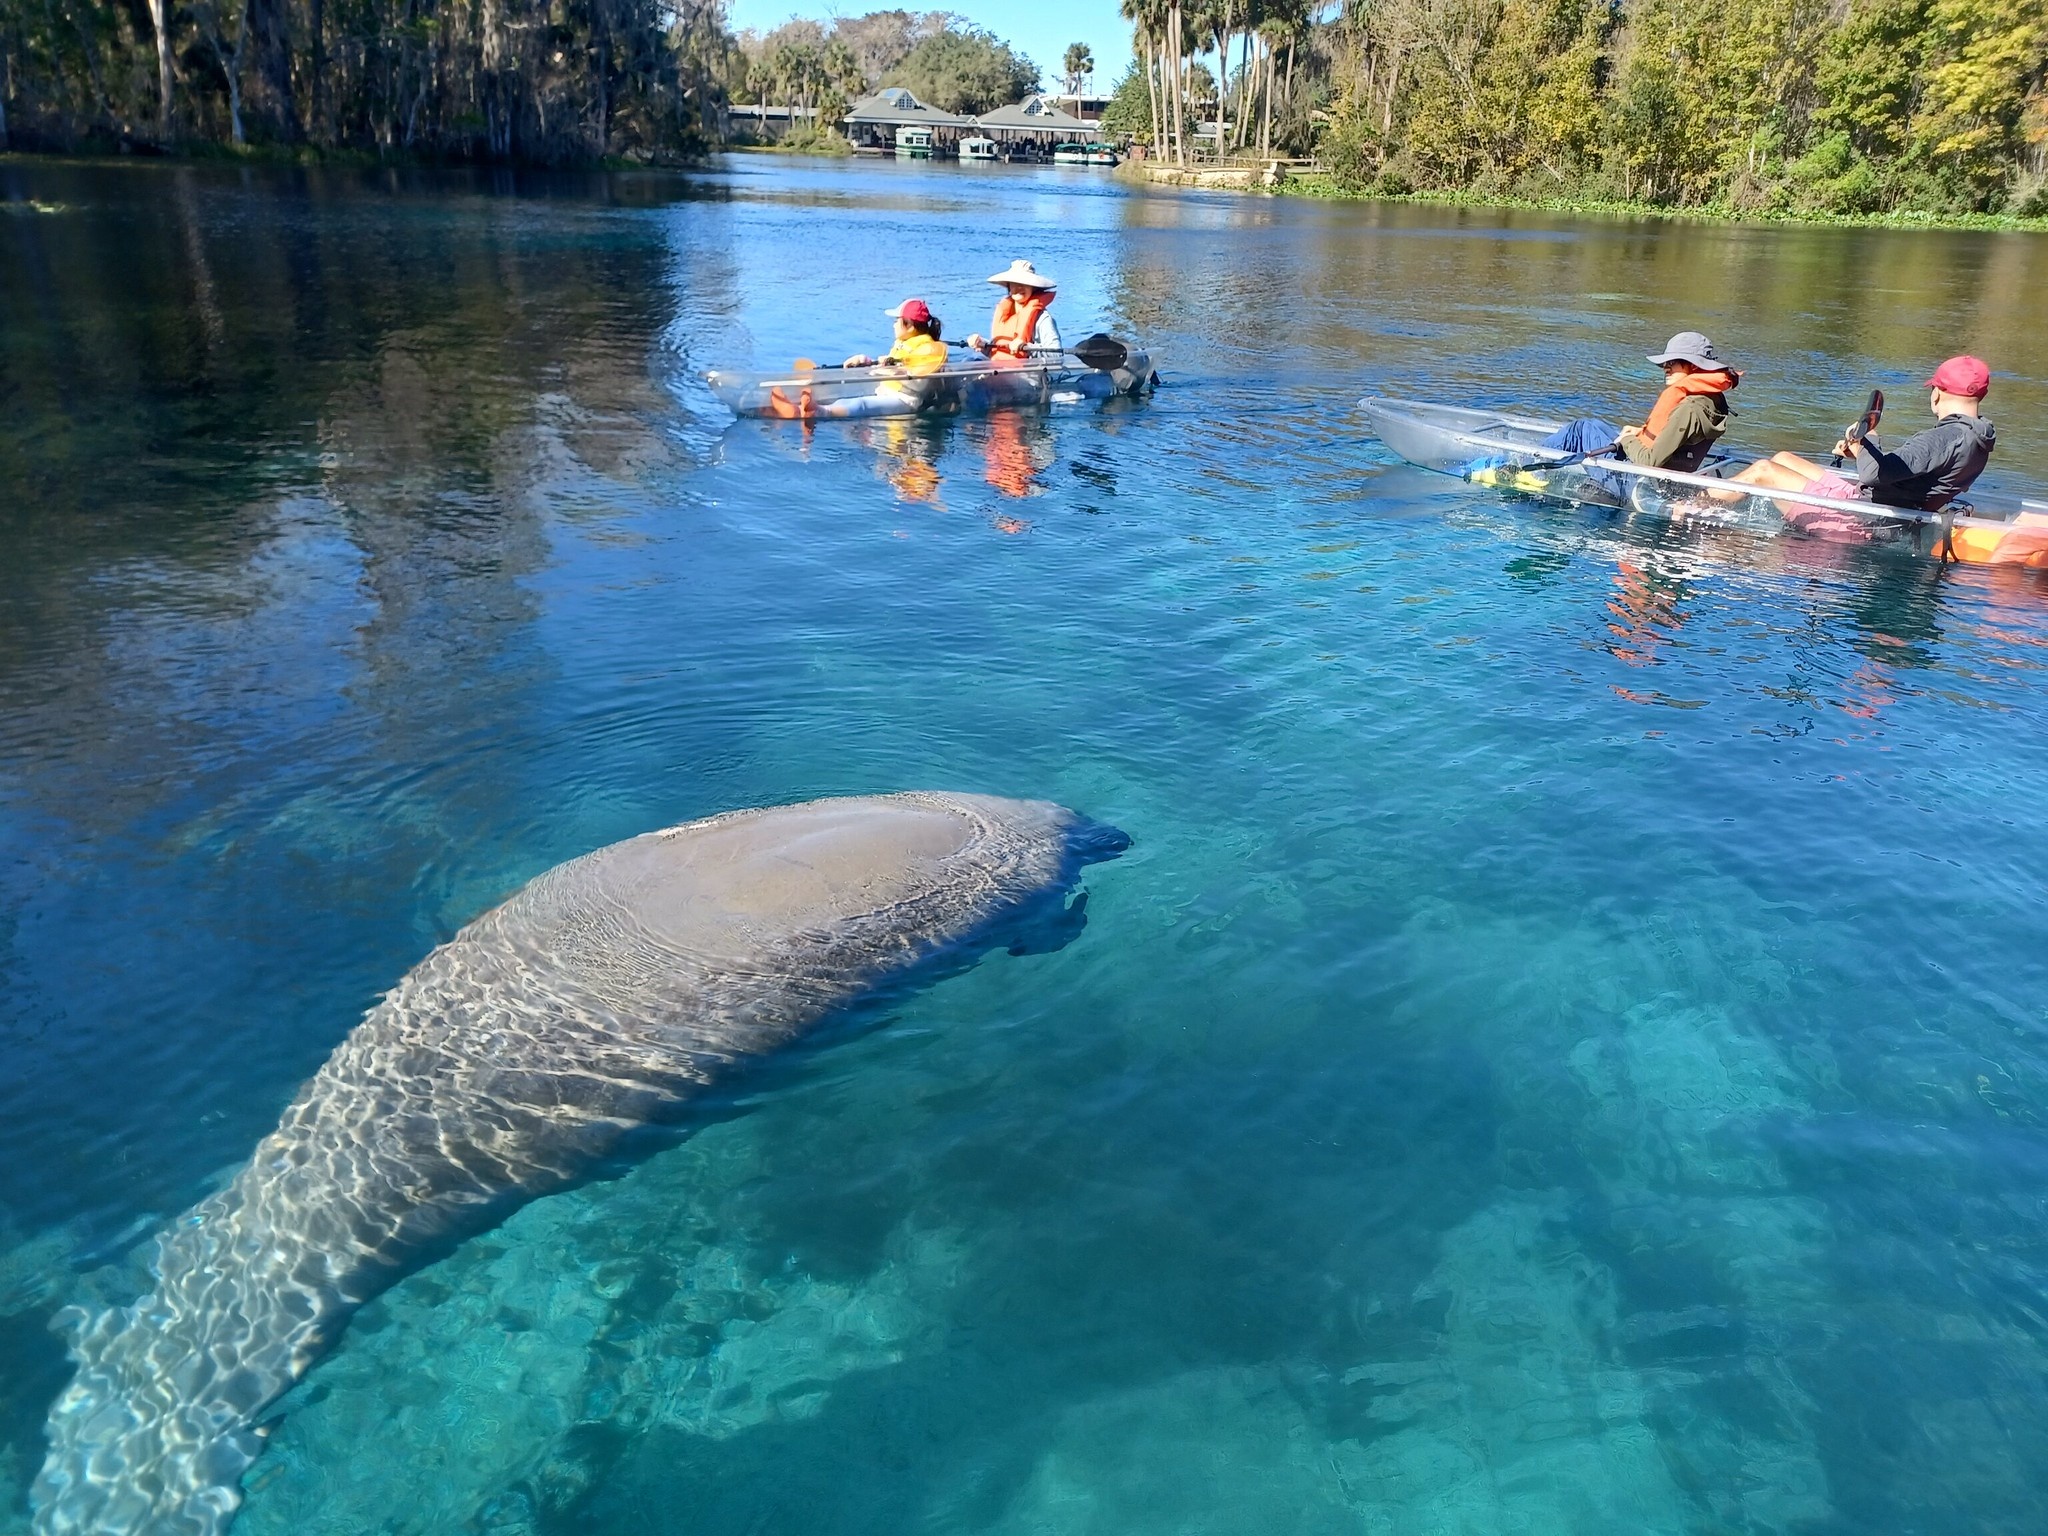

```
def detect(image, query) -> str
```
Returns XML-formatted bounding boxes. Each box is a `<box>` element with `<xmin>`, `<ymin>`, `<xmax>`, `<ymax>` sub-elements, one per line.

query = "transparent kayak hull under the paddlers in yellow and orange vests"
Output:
<box><xmin>705</xmin><ymin>348</ymin><xmax>1153</xmax><ymax>422</ymax></box>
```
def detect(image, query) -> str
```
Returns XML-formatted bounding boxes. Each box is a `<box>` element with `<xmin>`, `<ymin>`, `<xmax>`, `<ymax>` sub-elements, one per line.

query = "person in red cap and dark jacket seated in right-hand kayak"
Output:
<box><xmin>1716</xmin><ymin>356</ymin><xmax>1997</xmax><ymax>516</ymax></box>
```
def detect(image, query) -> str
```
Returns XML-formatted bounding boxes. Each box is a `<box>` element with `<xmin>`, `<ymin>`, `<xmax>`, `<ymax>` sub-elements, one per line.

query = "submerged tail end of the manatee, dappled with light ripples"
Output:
<box><xmin>31</xmin><ymin>1188</ymin><xmax>350</xmax><ymax>1536</ymax></box>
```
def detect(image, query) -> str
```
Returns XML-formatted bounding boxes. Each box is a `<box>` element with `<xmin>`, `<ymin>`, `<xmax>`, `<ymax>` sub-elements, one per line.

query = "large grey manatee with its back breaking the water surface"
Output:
<box><xmin>33</xmin><ymin>795</ymin><xmax>1128</xmax><ymax>1536</ymax></box>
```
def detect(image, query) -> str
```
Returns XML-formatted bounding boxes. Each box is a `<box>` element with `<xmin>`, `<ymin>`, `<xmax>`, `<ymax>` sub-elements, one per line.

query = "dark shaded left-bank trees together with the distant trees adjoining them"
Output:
<box><xmin>0</xmin><ymin>0</ymin><xmax>1038</xmax><ymax>164</ymax></box>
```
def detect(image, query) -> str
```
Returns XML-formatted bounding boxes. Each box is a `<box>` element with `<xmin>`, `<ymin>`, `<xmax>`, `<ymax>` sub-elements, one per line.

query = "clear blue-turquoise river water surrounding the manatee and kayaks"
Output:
<box><xmin>12</xmin><ymin>160</ymin><xmax>2048</xmax><ymax>1536</ymax></box>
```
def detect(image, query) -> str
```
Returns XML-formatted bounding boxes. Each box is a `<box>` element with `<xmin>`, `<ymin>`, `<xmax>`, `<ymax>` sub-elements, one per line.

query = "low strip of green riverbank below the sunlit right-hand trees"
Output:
<box><xmin>1116</xmin><ymin>162</ymin><xmax>2048</xmax><ymax>233</ymax></box>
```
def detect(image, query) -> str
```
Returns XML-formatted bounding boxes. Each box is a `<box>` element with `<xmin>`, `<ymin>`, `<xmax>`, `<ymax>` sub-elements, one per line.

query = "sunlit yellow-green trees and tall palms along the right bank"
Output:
<box><xmin>1112</xmin><ymin>0</ymin><xmax>2048</xmax><ymax>215</ymax></box>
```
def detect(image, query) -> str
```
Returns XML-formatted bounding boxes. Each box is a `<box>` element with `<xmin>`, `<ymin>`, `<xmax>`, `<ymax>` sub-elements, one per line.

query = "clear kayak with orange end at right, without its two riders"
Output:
<box><xmin>1358</xmin><ymin>395</ymin><xmax>2048</xmax><ymax>571</ymax></box>
